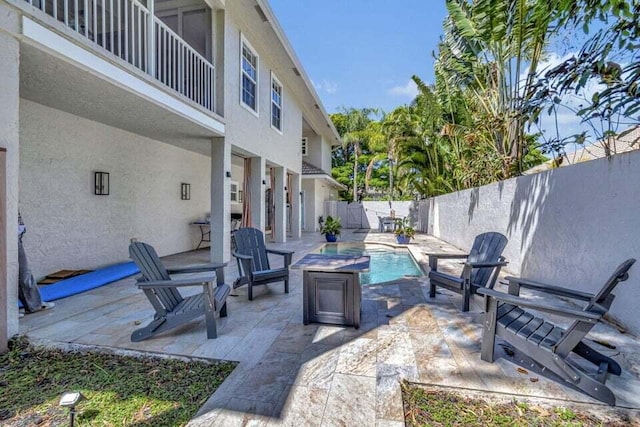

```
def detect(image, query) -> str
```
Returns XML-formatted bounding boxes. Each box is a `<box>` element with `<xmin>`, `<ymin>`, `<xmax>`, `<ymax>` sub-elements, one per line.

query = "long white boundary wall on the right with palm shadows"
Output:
<box><xmin>423</xmin><ymin>151</ymin><xmax>640</xmax><ymax>333</ymax></box>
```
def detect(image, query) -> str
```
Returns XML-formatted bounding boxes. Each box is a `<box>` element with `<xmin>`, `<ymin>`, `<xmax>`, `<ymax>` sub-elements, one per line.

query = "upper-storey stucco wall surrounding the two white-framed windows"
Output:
<box><xmin>224</xmin><ymin>2</ymin><xmax>302</xmax><ymax>173</ymax></box>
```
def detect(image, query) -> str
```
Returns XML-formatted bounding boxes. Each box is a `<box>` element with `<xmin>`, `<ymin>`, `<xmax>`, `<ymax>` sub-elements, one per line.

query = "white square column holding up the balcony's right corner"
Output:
<box><xmin>210</xmin><ymin>138</ymin><xmax>231</xmax><ymax>262</ymax></box>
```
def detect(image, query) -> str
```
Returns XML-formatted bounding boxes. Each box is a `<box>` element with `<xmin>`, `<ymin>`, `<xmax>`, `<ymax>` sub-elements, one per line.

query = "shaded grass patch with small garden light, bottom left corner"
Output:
<box><xmin>0</xmin><ymin>338</ymin><xmax>236</xmax><ymax>426</ymax></box>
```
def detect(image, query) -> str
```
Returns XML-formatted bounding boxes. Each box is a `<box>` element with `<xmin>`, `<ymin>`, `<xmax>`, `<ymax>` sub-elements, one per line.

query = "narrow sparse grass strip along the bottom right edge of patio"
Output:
<box><xmin>402</xmin><ymin>382</ymin><xmax>638</xmax><ymax>427</ymax></box>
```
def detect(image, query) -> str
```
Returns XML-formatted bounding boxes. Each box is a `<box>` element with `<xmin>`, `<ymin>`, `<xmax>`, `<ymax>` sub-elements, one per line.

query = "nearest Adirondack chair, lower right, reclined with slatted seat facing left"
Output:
<box><xmin>478</xmin><ymin>259</ymin><xmax>636</xmax><ymax>406</ymax></box>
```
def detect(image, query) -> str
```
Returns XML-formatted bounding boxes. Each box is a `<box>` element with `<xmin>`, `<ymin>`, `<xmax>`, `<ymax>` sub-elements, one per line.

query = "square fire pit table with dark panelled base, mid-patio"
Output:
<box><xmin>291</xmin><ymin>254</ymin><xmax>370</xmax><ymax>329</ymax></box>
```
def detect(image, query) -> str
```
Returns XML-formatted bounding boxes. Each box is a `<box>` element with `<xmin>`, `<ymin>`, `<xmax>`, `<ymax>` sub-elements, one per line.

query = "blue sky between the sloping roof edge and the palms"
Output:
<box><xmin>270</xmin><ymin>0</ymin><xmax>446</xmax><ymax>113</ymax></box>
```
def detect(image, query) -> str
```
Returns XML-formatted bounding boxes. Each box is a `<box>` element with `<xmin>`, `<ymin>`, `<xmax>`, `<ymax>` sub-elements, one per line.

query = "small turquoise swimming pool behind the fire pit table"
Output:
<box><xmin>317</xmin><ymin>243</ymin><xmax>423</xmax><ymax>285</ymax></box>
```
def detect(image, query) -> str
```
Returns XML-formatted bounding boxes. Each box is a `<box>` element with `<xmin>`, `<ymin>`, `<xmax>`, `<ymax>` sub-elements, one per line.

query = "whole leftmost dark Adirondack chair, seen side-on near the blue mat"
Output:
<box><xmin>129</xmin><ymin>242</ymin><xmax>231</xmax><ymax>342</ymax></box>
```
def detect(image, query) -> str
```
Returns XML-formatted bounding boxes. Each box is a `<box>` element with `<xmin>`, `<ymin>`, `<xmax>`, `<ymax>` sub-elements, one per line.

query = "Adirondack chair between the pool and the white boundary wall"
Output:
<box><xmin>427</xmin><ymin>232</ymin><xmax>507</xmax><ymax>311</ymax></box>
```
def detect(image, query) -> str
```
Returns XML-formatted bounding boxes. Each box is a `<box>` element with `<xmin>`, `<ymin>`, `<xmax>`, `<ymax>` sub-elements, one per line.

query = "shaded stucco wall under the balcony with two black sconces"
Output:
<box><xmin>20</xmin><ymin>99</ymin><xmax>211</xmax><ymax>277</ymax></box>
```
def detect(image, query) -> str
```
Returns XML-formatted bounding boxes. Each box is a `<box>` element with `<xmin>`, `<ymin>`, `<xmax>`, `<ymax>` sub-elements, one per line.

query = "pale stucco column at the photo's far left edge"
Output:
<box><xmin>0</xmin><ymin>31</ymin><xmax>20</xmax><ymax>353</ymax></box>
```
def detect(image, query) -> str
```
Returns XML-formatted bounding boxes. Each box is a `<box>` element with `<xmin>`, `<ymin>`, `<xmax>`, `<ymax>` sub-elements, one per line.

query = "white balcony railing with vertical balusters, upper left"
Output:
<box><xmin>26</xmin><ymin>0</ymin><xmax>215</xmax><ymax>111</ymax></box>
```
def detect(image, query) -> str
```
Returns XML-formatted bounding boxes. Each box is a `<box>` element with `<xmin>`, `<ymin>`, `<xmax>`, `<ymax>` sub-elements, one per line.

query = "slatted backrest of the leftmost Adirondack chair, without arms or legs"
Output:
<box><xmin>129</xmin><ymin>242</ymin><xmax>183</xmax><ymax>312</ymax></box>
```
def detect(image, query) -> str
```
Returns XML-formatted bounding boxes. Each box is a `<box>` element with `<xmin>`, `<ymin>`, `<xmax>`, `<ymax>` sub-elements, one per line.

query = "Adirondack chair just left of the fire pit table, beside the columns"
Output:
<box><xmin>231</xmin><ymin>228</ymin><xmax>294</xmax><ymax>301</ymax></box>
